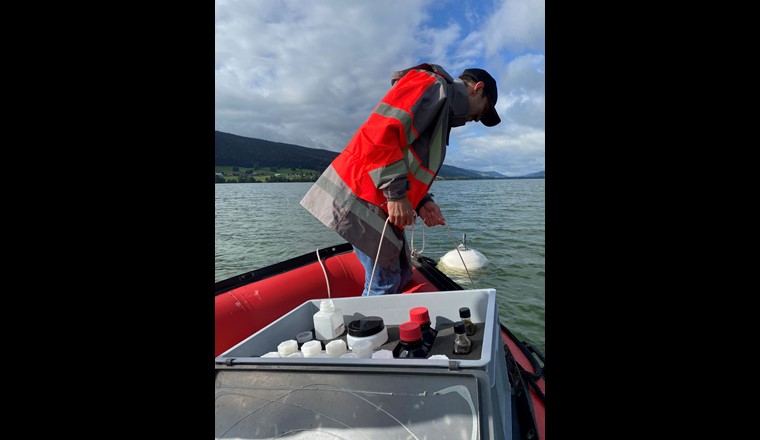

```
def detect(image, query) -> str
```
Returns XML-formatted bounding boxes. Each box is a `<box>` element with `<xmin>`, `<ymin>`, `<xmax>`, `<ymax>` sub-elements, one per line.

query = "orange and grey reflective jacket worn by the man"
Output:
<box><xmin>301</xmin><ymin>64</ymin><xmax>455</xmax><ymax>265</ymax></box>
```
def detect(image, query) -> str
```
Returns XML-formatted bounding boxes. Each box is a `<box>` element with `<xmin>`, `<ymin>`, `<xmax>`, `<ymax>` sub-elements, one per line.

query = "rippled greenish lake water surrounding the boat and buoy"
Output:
<box><xmin>215</xmin><ymin>179</ymin><xmax>545</xmax><ymax>352</ymax></box>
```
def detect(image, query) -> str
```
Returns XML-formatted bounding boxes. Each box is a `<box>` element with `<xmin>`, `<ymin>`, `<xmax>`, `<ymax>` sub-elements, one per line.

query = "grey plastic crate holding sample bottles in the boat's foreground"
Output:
<box><xmin>215</xmin><ymin>289</ymin><xmax>512</xmax><ymax>440</ymax></box>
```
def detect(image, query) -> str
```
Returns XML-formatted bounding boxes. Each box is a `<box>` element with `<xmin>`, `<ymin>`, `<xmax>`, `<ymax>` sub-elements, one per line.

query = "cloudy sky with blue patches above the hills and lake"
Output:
<box><xmin>214</xmin><ymin>0</ymin><xmax>545</xmax><ymax>176</ymax></box>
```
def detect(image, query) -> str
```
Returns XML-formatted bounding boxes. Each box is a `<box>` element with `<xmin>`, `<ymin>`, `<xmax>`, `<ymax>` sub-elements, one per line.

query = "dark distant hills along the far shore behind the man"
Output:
<box><xmin>214</xmin><ymin>130</ymin><xmax>544</xmax><ymax>179</ymax></box>
